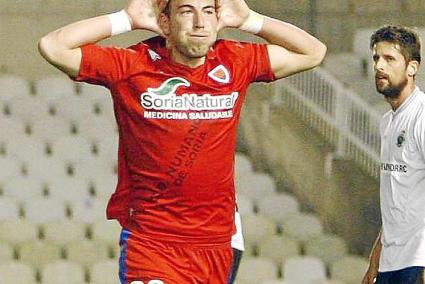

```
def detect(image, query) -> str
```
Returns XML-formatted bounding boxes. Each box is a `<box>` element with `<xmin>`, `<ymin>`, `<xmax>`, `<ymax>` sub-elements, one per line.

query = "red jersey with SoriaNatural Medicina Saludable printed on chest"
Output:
<box><xmin>76</xmin><ymin>37</ymin><xmax>274</xmax><ymax>243</ymax></box>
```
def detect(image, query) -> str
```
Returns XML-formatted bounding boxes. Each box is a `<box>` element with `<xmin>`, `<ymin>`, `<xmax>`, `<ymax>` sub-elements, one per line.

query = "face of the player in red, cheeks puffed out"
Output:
<box><xmin>161</xmin><ymin>0</ymin><xmax>217</xmax><ymax>58</ymax></box>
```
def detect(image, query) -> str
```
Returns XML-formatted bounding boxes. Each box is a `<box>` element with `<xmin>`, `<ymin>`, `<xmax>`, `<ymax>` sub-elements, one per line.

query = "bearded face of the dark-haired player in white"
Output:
<box><xmin>373</xmin><ymin>41</ymin><xmax>408</xmax><ymax>98</ymax></box>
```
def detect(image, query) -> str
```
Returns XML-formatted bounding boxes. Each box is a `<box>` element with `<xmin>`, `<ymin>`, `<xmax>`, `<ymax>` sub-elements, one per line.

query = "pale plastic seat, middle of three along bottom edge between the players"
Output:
<box><xmin>282</xmin><ymin>256</ymin><xmax>327</xmax><ymax>284</ymax></box>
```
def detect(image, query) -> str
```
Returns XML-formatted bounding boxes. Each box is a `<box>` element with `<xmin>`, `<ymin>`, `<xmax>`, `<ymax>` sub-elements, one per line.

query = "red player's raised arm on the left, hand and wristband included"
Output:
<box><xmin>38</xmin><ymin>0</ymin><xmax>166</xmax><ymax>77</ymax></box>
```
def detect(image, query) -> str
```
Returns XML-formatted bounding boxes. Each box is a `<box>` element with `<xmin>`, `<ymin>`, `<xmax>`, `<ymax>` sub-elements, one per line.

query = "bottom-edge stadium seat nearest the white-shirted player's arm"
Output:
<box><xmin>330</xmin><ymin>255</ymin><xmax>369</xmax><ymax>284</ymax></box>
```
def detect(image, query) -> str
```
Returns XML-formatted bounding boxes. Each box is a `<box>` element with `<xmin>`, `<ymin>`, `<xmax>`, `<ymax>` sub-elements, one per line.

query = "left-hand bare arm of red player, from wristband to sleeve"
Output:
<box><xmin>38</xmin><ymin>16</ymin><xmax>115</xmax><ymax>76</ymax></box>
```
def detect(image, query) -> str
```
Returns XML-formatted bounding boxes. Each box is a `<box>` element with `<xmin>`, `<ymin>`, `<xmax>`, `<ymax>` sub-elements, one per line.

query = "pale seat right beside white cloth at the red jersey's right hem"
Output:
<box><xmin>242</xmin><ymin>215</ymin><xmax>276</xmax><ymax>245</ymax></box>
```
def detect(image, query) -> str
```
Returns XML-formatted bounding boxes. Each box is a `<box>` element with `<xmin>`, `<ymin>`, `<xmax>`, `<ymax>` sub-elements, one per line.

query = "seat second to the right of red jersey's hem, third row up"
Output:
<box><xmin>282</xmin><ymin>213</ymin><xmax>323</xmax><ymax>242</ymax></box>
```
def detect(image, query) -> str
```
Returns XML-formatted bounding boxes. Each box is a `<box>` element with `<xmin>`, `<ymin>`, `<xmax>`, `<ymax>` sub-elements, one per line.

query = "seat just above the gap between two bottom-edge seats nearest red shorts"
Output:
<box><xmin>258</xmin><ymin>235</ymin><xmax>301</xmax><ymax>266</ymax></box>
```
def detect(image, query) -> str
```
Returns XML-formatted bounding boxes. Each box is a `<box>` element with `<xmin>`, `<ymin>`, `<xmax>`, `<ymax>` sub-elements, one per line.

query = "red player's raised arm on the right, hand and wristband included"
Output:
<box><xmin>217</xmin><ymin>0</ymin><xmax>326</xmax><ymax>78</ymax></box>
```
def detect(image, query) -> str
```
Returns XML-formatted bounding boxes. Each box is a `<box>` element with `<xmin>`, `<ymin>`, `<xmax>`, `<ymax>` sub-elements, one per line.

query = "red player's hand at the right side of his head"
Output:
<box><xmin>215</xmin><ymin>0</ymin><xmax>249</xmax><ymax>30</ymax></box>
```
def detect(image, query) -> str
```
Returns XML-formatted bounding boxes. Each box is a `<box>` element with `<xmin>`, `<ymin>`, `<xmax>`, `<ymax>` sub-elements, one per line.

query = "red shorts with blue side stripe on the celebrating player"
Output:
<box><xmin>119</xmin><ymin>230</ymin><xmax>233</xmax><ymax>284</ymax></box>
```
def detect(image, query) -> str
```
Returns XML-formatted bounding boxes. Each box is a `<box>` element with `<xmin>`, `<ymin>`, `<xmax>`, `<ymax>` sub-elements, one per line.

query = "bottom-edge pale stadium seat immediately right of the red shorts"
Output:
<box><xmin>237</xmin><ymin>256</ymin><xmax>278</xmax><ymax>284</ymax></box>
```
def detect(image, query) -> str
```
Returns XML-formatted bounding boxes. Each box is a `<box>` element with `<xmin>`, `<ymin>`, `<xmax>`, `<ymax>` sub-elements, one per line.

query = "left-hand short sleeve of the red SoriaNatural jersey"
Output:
<box><xmin>73</xmin><ymin>44</ymin><xmax>137</xmax><ymax>88</ymax></box>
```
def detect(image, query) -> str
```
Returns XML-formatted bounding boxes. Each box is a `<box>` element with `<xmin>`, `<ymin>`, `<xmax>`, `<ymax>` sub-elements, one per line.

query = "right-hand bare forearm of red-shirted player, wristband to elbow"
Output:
<box><xmin>257</xmin><ymin>17</ymin><xmax>326</xmax><ymax>67</ymax></box>
